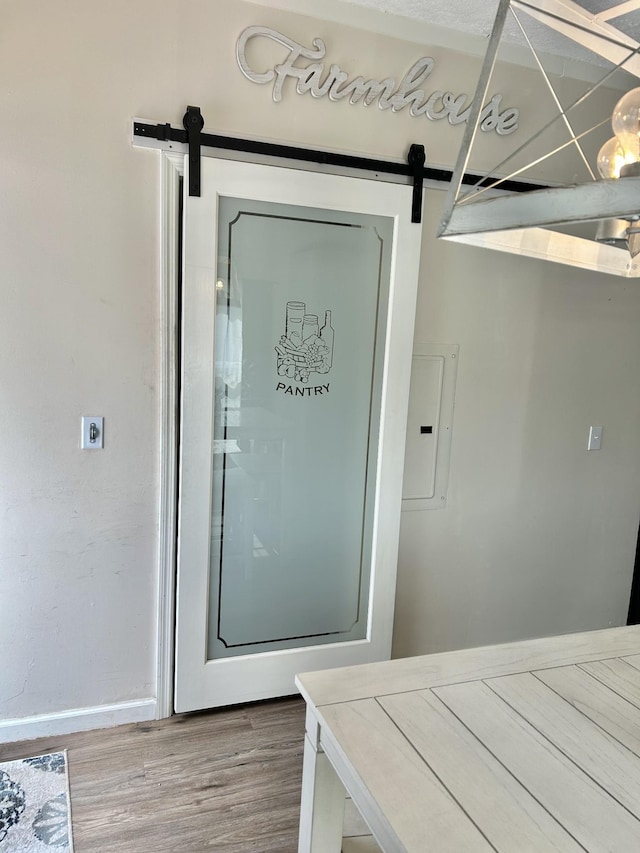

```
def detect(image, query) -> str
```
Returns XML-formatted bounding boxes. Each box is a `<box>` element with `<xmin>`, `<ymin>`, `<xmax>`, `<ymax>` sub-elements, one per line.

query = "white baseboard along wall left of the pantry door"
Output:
<box><xmin>0</xmin><ymin>699</ymin><xmax>157</xmax><ymax>743</ymax></box>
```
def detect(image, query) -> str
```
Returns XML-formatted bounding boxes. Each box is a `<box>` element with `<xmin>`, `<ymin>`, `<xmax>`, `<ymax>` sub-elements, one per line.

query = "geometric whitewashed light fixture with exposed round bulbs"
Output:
<box><xmin>438</xmin><ymin>0</ymin><xmax>640</xmax><ymax>278</ymax></box>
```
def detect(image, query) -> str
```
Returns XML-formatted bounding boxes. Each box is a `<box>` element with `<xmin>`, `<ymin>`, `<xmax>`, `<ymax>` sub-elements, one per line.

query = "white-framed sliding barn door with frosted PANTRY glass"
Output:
<box><xmin>175</xmin><ymin>158</ymin><xmax>421</xmax><ymax>711</ymax></box>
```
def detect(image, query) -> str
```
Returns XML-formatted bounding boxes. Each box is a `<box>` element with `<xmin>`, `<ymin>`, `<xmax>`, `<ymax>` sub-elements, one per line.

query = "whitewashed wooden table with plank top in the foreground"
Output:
<box><xmin>296</xmin><ymin>626</ymin><xmax>640</xmax><ymax>853</ymax></box>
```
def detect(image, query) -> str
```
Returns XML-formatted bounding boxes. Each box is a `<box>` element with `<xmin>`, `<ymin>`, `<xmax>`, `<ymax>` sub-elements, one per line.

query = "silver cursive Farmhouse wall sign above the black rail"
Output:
<box><xmin>236</xmin><ymin>26</ymin><xmax>520</xmax><ymax>136</ymax></box>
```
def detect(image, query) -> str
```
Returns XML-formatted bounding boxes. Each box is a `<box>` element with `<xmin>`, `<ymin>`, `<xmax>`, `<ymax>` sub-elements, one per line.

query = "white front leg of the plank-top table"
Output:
<box><xmin>298</xmin><ymin>710</ymin><xmax>346</xmax><ymax>853</ymax></box>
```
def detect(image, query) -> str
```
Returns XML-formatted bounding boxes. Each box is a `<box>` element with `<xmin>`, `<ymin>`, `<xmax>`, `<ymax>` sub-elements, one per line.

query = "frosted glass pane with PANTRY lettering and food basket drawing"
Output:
<box><xmin>208</xmin><ymin>197</ymin><xmax>393</xmax><ymax>660</ymax></box>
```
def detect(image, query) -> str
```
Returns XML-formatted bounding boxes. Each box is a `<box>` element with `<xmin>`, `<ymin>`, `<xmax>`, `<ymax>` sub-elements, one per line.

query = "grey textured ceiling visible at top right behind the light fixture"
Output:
<box><xmin>338</xmin><ymin>0</ymin><xmax>640</xmax><ymax>64</ymax></box>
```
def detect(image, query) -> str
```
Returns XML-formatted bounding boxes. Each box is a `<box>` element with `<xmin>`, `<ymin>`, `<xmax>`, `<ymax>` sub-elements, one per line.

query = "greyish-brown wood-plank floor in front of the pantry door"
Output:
<box><xmin>0</xmin><ymin>698</ymin><xmax>305</xmax><ymax>853</ymax></box>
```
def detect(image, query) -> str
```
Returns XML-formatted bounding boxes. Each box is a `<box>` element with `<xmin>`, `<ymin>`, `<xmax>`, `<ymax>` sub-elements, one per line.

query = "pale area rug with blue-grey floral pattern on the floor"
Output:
<box><xmin>0</xmin><ymin>752</ymin><xmax>73</xmax><ymax>853</ymax></box>
